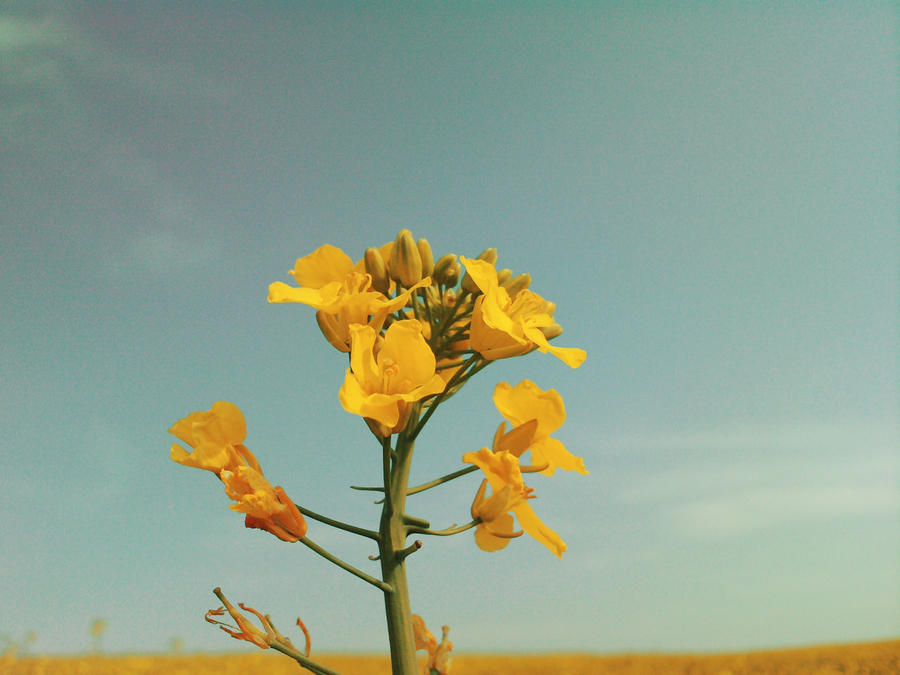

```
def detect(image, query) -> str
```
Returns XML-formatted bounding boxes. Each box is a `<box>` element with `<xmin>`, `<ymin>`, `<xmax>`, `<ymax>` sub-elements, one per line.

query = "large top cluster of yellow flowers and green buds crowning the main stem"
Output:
<box><xmin>269</xmin><ymin>230</ymin><xmax>585</xmax><ymax>437</ymax></box>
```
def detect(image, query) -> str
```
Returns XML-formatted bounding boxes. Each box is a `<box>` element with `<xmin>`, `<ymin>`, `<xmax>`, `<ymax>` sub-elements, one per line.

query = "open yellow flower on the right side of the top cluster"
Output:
<box><xmin>460</xmin><ymin>256</ymin><xmax>587</xmax><ymax>368</ymax></box>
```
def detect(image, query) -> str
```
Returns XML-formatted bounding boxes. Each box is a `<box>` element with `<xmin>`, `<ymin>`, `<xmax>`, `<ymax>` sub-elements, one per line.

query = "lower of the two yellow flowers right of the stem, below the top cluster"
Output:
<box><xmin>463</xmin><ymin>448</ymin><xmax>566</xmax><ymax>558</ymax></box>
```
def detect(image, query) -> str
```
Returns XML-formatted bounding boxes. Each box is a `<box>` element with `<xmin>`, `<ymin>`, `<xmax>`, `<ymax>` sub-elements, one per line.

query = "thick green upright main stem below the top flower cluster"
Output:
<box><xmin>379</xmin><ymin>426</ymin><xmax>417</xmax><ymax>675</ymax></box>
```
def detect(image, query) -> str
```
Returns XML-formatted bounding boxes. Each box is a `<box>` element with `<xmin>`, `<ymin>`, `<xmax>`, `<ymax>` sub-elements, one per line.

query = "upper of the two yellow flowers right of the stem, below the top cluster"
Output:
<box><xmin>494</xmin><ymin>380</ymin><xmax>588</xmax><ymax>476</ymax></box>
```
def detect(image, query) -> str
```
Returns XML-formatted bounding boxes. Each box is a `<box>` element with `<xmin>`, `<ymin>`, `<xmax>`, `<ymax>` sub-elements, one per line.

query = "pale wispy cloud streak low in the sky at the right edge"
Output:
<box><xmin>613</xmin><ymin>421</ymin><xmax>900</xmax><ymax>539</ymax></box>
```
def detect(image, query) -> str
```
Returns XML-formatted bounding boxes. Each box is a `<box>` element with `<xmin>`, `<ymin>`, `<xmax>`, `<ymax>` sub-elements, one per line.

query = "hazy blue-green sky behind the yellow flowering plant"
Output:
<box><xmin>0</xmin><ymin>2</ymin><xmax>900</xmax><ymax>652</ymax></box>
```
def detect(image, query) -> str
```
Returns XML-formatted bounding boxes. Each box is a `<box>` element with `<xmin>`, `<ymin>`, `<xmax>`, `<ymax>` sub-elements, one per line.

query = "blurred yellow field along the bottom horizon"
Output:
<box><xmin>0</xmin><ymin>640</ymin><xmax>900</xmax><ymax>675</ymax></box>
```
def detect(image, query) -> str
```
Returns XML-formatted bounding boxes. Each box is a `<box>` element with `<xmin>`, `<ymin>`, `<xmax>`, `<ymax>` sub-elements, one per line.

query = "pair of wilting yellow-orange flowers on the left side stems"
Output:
<box><xmin>169</xmin><ymin>401</ymin><xmax>306</xmax><ymax>542</ymax></box>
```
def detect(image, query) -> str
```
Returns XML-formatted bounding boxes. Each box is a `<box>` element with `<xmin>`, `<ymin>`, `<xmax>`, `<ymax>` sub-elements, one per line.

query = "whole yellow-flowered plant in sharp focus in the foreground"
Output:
<box><xmin>168</xmin><ymin>230</ymin><xmax>587</xmax><ymax>675</ymax></box>
